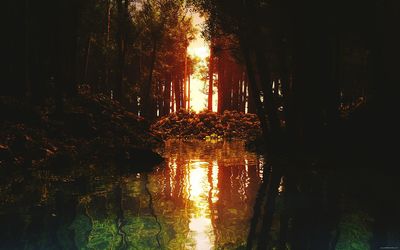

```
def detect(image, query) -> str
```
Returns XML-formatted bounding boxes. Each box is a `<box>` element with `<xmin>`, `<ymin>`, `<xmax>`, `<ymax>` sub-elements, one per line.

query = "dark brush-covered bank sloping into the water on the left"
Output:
<box><xmin>0</xmin><ymin>95</ymin><xmax>162</xmax><ymax>176</ymax></box>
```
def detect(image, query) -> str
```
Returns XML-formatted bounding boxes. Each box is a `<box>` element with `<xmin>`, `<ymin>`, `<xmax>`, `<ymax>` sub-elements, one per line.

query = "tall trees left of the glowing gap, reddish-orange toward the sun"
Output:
<box><xmin>1</xmin><ymin>0</ymin><xmax>200</xmax><ymax>118</ymax></box>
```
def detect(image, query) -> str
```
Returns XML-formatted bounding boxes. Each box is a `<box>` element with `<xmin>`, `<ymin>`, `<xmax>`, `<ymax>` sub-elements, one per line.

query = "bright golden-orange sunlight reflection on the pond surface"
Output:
<box><xmin>139</xmin><ymin>141</ymin><xmax>263</xmax><ymax>249</ymax></box>
